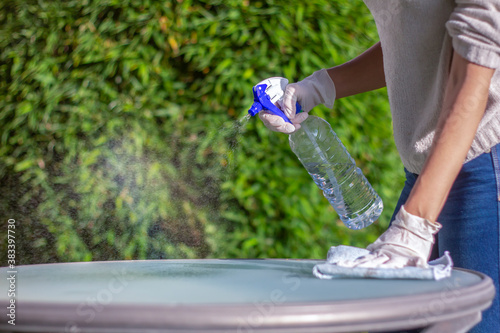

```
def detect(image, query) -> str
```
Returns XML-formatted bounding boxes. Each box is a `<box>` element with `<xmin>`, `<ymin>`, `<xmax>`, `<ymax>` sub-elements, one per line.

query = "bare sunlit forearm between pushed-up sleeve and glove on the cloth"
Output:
<box><xmin>405</xmin><ymin>52</ymin><xmax>495</xmax><ymax>221</ymax></box>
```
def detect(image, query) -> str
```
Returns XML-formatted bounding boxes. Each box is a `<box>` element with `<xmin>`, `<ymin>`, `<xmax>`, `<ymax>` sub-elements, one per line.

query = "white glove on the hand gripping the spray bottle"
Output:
<box><xmin>259</xmin><ymin>69</ymin><xmax>335</xmax><ymax>134</ymax></box>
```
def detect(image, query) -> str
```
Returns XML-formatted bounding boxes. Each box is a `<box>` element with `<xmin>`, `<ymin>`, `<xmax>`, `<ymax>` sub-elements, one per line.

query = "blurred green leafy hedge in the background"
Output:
<box><xmin>0</xmin><ymin>0</ymin><xmax>403</xmax><ymax>265</ymax></box>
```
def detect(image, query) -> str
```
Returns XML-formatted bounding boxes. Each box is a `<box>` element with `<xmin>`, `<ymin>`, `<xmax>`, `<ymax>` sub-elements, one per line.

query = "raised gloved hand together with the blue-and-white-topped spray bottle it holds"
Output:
<box><xmin>248</xmin><ymin>70</ymin><xmax>383</xmax><ymax>229</ymax></box>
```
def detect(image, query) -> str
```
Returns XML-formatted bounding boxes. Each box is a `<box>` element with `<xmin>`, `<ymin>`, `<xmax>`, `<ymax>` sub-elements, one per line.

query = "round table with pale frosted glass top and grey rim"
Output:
<box><xmin>0</xmin><ymin>259</ymin><xmax>495</xmax><ymax>333</ymax></box>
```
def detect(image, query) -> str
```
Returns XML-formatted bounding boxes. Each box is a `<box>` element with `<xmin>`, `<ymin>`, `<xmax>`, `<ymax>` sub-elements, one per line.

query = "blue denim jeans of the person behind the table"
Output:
<box><xmin>392</xmin><ymin>144</ymin><xmax>500</xmax><ymax>333</ymax></box>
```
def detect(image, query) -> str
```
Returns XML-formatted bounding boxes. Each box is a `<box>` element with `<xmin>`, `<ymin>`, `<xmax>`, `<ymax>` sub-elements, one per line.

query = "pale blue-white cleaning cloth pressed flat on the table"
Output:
<box><xmin>313</xmin><ymin>245</ymin><xmax>453</xmax><ymax>280</ymax></box>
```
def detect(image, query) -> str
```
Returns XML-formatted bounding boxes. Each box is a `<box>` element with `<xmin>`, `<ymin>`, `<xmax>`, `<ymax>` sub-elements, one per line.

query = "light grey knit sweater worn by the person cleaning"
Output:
<box><xmin>364</xmin><ymin>0</ymin><xmax>500</xmax><ymax>174</ymax></box>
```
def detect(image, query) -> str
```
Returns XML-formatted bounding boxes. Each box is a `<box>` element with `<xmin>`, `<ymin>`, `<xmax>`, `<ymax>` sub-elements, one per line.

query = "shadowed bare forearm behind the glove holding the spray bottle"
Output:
<box><xmin>328</xmin><ymin>42</ymin><xmax>385</xmax><ymax>98</ymax></box>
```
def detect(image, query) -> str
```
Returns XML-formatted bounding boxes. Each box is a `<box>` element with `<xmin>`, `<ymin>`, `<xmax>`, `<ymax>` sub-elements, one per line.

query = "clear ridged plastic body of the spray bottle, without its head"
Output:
<box><xmin>289</xmin><ymin>115</ymin><xmax>383</xmax><ymax>229</ymax></box>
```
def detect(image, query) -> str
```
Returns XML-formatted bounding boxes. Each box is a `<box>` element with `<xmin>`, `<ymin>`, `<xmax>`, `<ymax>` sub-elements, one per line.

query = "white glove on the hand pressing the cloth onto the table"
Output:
<box><xmin>337</xmin><ymin>206</ymin><xmax>441</xmax><ymax>268</ymax></box>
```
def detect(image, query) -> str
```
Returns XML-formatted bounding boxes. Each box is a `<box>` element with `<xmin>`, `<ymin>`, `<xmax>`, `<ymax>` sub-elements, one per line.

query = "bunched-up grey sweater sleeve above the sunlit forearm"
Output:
<box><xmin>446</xmin><ymin>0</ymin><xmax>500</xmax><ymax>68</ymax></box>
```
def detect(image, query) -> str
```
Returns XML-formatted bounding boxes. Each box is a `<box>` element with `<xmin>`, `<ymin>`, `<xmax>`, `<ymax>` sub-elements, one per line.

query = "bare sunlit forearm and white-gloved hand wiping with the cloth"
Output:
<box><xmin>339</xmin><ymin>53</ymin><xmax>495</xmax><ymax>268</ymax></box>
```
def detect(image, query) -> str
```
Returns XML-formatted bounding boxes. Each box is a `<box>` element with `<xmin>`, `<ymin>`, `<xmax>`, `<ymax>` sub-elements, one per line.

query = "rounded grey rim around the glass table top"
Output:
<box><xmin>0</xmin><ymin>260</ymin><xmax>495</xmax><ymax>333</ymax></box>
